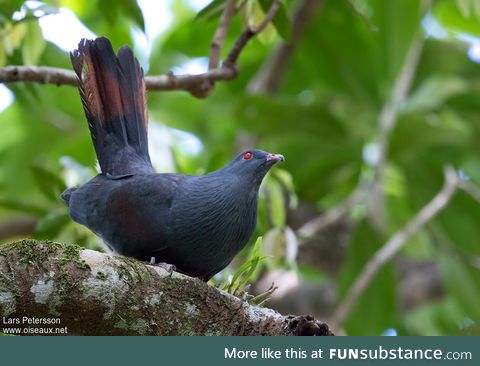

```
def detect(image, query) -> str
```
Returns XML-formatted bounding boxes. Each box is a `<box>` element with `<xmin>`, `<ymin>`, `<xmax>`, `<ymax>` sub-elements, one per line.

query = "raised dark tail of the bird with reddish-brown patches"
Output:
<box><xmin>70</xmin><ymin>37</ymin><xmax>152</xmax><ymax>176</ymax></box>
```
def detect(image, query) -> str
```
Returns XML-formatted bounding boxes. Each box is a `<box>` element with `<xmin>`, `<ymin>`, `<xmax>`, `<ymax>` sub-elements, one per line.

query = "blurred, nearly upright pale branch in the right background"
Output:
<box><xmin>368</xmin><ymin>35</ymin><xmax>423</xmax><ymax>231</ymax></box>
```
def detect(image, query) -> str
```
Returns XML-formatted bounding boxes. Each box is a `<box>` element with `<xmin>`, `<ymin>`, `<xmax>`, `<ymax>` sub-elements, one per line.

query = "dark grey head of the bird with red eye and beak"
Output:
<box><xmin>225</xmin><ymin>149</ymin><xmax>285</xmax><ymax>183</ymax></box>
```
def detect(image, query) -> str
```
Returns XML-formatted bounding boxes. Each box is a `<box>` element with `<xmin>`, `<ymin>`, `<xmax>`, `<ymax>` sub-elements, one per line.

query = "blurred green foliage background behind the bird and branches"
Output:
<box><xmin>0</xmin><ymin>0</ymin><xmax>480</xmax><ymax>335</ymax></box>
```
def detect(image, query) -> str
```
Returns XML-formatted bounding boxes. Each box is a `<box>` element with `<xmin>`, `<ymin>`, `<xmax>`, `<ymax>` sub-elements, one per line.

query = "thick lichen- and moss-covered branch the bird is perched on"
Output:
<box><xmin>0</xmin><ymin>240</ymin><xmax>331</xmax><ymax>335</ymax></box>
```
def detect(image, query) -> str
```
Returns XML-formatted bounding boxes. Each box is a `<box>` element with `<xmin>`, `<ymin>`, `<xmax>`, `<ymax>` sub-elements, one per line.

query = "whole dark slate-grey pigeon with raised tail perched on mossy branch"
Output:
<box><xmin>61</xmin><ymin>37</ymin><xmax>284</xmax><ymax>281</ymax></box>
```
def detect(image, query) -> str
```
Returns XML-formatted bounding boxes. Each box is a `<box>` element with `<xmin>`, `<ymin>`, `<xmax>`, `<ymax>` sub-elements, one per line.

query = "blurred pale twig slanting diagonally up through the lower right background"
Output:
<box><xmin>330</xmin><ymin>167</ymin><xmax>461</xmax><ymax>329</ymax></box>
